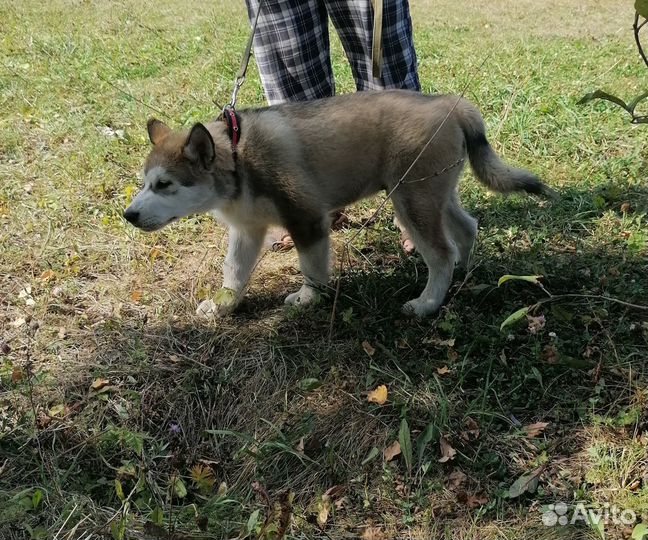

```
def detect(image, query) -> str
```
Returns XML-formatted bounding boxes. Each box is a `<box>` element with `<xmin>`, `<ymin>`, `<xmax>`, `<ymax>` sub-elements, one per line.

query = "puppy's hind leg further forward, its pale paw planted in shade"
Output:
<box><xmin>394</xmin><ymin>193</ymin><xmax>457</xmax><ymax>317</ymax></box>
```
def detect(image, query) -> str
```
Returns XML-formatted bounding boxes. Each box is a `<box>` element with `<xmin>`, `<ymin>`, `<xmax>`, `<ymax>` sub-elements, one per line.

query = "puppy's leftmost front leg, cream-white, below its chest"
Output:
<box><xmin>197</xmin><ymin>227</ymin><xmax>266</xmax><ymax>317</ymax></box>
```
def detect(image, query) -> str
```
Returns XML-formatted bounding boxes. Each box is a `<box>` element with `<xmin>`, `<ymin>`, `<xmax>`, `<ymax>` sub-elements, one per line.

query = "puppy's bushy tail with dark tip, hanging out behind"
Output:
<box><xmin>457</xmin><ymin>100</ymin><xmax>558</xmax><ymax>199</ymax></box>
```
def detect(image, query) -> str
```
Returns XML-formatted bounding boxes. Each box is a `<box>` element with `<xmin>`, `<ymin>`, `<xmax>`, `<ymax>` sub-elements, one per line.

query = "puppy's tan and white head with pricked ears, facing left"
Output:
<box><xmin>124</xmin><ymin>118</ymin><xmax>236</xmax><ymax>231</ymax></box>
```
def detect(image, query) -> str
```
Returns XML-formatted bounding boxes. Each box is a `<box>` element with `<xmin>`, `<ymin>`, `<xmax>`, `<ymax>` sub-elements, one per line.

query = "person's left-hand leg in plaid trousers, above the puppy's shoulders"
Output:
<box><xmin>246</xmin><ymin>0</ymin><xmax>335</xmax><ymax>105</ymax></box>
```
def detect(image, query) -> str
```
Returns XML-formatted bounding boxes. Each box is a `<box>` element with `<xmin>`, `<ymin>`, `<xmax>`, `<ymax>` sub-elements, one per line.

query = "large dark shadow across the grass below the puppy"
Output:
<box><xmin>3</xmin><ymin>182</ymin><xmax>648</xmax><ymax>538</ymax></box>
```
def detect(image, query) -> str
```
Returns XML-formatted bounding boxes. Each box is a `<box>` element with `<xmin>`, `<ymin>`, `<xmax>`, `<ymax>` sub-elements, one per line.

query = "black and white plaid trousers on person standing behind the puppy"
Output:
<box><xmin>246</xmin><ymin>0</ymin><xmax>420</xmax><ymax>104</ymax></box>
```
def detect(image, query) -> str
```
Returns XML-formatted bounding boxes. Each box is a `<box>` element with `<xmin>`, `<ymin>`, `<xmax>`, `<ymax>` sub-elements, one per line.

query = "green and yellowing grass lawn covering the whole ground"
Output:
<box><xmin>0</xmin><ymin>0</ymin><xmax>648</xmax><ymax>540</ymax></box>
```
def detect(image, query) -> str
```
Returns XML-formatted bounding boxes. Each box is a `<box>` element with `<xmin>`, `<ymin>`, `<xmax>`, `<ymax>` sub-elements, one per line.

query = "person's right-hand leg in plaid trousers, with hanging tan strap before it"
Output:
<box><xmin>324</xmin><ymin>0</ymin><xmax>421</xmax><ymax>91</ymax></box>
